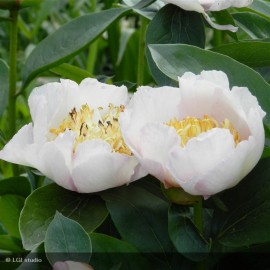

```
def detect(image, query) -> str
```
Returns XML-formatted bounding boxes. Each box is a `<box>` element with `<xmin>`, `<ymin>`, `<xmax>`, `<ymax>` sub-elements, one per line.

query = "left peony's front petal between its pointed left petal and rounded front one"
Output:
<box><xmin>38</xmin><ymin>131</ymin><xmax>77</xmax><ymax>191</ymax></box>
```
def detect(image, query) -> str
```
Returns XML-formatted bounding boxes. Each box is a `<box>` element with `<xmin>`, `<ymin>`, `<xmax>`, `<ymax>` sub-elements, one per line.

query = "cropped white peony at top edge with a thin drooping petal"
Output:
<box><xmin>162</xmin><ymin>0</ymin><xmax>253</xmax><ymax>32</ymax></box>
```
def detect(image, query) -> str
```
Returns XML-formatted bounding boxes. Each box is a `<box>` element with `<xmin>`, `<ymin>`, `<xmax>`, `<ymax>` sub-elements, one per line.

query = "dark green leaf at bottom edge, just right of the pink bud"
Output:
<box><xmin>90</xmin><ymin>233</ymin><xmax>151</xmax><ymax>270</ymax></box>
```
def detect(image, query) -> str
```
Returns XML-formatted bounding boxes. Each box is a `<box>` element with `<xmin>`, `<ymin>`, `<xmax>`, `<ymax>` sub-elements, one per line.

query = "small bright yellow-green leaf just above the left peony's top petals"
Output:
<box><xmin>51</xmin><ymin>63</ymin><xmax>93</xmax><ymax>83</ymax></box>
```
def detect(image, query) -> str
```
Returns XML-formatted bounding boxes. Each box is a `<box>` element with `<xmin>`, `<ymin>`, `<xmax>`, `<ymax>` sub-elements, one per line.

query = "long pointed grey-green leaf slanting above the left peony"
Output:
<box><xmin>23</xmin><ymin>8</ymin><xmax>130</xmax><ymax>85</ymax></box>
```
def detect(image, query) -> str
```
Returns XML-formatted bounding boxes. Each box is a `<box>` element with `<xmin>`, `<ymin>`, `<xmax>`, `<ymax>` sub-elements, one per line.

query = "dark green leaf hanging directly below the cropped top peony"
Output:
<box><xmin>146</xmin><ymin>5</ymin><xmax>205</xmax><ymax>85</ymax></box>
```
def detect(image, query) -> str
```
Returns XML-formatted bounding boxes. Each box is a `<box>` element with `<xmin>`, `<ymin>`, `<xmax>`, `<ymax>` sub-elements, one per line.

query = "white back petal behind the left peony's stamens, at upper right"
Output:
<box><xmin>79</xmin><ymin>78</ymin><xmax>128</xmax><ymax>108</ymax></box>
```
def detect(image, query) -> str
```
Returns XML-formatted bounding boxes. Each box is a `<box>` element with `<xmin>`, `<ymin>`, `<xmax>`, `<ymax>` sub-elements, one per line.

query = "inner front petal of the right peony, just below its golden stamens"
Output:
<box><xmin>168</xmin><ymin>128</ymin><xmax>235</xmax><ymax>188</ymax></box>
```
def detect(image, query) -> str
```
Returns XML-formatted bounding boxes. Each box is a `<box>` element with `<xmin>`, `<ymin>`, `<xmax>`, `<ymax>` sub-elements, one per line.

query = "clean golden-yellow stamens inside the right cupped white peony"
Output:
<box><xmin>166</xmin><ymin>115</ymin><xmax>240</xmax><ymax>147</ymax></box>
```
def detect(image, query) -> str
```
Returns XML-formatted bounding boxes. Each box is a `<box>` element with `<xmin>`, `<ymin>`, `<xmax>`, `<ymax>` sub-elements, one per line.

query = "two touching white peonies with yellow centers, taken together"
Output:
<box><xmin>0</xmin><ymin>71</ymin><xmax>265</xmax><ymax>197</ymax></box>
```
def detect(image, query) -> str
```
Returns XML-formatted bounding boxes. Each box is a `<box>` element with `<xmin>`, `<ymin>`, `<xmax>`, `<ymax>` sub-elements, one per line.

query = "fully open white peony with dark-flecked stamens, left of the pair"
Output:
<box><xmin>0</xmin><ymin>78</ymin><xmax>142</xmax><ymax>193</ymax></box>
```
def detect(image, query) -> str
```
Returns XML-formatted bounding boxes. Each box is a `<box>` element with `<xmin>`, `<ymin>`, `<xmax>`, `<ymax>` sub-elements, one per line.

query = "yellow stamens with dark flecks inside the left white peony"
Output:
<box><xmin>50</xmin><ymin>104</ymin><xmax>132</xmax><ymax>156</ymax></box>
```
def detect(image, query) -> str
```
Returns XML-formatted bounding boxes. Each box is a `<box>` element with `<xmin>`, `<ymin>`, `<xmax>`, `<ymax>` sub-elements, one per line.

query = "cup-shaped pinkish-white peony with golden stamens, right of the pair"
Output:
<box><xmin>120</xmin><ymin>71</ymin><xmax>265</xmax><ymax>198</ymax></box>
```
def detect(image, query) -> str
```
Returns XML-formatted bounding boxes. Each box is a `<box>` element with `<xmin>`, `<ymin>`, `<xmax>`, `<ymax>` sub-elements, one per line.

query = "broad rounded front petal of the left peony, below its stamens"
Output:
<box><xmin>72</xmin><ymin>140</ymin><xmax>138</xmax><ymax>193</ymax></box>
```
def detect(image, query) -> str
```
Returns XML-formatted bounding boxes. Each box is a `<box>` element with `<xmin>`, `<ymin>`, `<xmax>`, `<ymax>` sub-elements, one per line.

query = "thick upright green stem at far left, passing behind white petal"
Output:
<box><xmin>8</xmin><ymin>9</ymin><xmax>18</xmax><ymax>175</ymax></box>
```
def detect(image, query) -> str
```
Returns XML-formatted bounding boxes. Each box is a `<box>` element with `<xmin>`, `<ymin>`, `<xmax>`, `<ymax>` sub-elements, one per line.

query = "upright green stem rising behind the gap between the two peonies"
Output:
<box><xmin>137</xmin><ymin>17</ymin><xmax>148</xmax><ymax>86</ymax></box>
